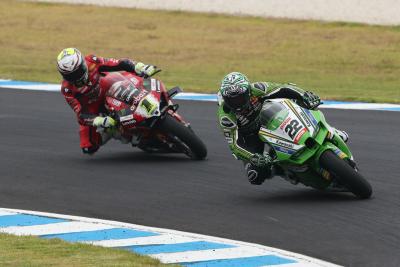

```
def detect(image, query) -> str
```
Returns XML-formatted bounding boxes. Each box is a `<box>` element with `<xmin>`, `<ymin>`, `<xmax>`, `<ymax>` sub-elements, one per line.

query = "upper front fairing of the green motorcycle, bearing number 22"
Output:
<box><xmin>259</xmin><ymin>99</ymin><xmax>352</xmax><ymax>164</ymax></box>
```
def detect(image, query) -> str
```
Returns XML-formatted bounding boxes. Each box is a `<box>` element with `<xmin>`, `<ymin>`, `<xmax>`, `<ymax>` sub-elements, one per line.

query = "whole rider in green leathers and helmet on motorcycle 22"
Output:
<box><xmin>218</xmin><ymin>72</ymin><xmax>348</xmax><ymax>185</ymax></box>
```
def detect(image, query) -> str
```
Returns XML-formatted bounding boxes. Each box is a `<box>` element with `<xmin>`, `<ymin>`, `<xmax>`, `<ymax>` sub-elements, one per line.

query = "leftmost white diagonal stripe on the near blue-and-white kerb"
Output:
<box><xmin>0</xmin><ymin>221</ymin><xmax>115</xmax><ymax>235</ymax></box>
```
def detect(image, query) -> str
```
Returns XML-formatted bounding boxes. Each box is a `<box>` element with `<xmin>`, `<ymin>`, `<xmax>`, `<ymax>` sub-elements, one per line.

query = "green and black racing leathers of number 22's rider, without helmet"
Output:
<box><xmin>218</xmin><ymin>82</ymin><xmax>320</xmax><ymax>185</ymax></box>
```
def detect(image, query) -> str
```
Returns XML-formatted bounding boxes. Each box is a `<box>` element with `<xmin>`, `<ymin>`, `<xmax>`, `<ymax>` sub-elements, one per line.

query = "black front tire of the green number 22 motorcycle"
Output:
<box><xmin>319</xmin><ymin>150</ymin><xmax>372</xmax><ymax>199</ymax></box>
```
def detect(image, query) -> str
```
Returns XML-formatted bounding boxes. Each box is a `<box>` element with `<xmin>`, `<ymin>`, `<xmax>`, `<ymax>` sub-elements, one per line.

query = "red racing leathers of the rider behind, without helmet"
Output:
<box><xmin>61</xmin><ymin>55</ymin><xmax>148</xmax><ymax>154</ymax></box>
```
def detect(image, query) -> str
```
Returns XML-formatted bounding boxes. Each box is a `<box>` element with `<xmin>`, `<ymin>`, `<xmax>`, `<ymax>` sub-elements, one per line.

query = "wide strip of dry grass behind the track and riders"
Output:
<box><xmin>0</xmin><ymin>0</ymin><xmax>400</xmax><ymax>103</ymax></box>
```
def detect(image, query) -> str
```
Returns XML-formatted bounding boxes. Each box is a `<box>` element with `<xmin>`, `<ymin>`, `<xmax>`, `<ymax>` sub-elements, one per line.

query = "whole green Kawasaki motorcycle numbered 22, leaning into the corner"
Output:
<box><xmin>258</xmin><ymin>99</ymin><xmax>372</xmax><ymax>199</ymax></box>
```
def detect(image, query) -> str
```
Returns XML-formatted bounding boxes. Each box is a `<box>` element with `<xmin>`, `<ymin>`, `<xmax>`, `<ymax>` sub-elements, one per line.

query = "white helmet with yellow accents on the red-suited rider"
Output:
<box><xmin>57</xmin><ymin>48</ymin><xmax>89</xmax><ymax>87</ymax></box>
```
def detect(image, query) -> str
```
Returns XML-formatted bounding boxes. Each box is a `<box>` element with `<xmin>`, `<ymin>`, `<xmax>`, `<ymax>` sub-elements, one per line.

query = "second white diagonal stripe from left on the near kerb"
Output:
<box><xmin>85</xmin><ymin>234</ymin><xmax>198</xmax><ymax>247</ymax></box>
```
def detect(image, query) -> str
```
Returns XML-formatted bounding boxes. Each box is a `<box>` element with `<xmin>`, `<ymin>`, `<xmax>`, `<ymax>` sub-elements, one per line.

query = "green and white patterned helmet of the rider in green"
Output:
<box><xmin>219</xmin><ymin>72</ymin><xmax>251</xmax><ymax>112</ymax></box>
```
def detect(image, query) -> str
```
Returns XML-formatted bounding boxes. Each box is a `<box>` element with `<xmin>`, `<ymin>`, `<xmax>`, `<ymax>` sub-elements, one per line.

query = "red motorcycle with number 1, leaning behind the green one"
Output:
<box><xmin>100</xmin><ymin>72</ymin><xmax>207</xmax><ymax>160</ymax></box>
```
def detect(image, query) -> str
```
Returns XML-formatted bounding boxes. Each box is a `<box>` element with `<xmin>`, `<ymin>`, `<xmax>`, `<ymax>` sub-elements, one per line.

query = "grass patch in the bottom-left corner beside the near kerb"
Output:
<box><xmin>0</xmin><ymin>234</ymin><xmax>178</xmax><ymax>267</ymax></box>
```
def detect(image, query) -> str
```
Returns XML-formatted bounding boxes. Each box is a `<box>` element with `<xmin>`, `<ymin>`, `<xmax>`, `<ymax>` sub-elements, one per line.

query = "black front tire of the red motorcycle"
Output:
<box><xmin>158</xmin><ymin>114</ymin><xmax>207</xmax><ymax>160</ymax></box>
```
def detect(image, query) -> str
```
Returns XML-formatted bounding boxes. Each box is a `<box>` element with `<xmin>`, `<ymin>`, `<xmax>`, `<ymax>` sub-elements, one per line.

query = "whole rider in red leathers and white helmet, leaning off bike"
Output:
<box><xmin>57</xmin><ymin>48</ymin><xmax>159</xmax><ymax>155</ymax></box>
